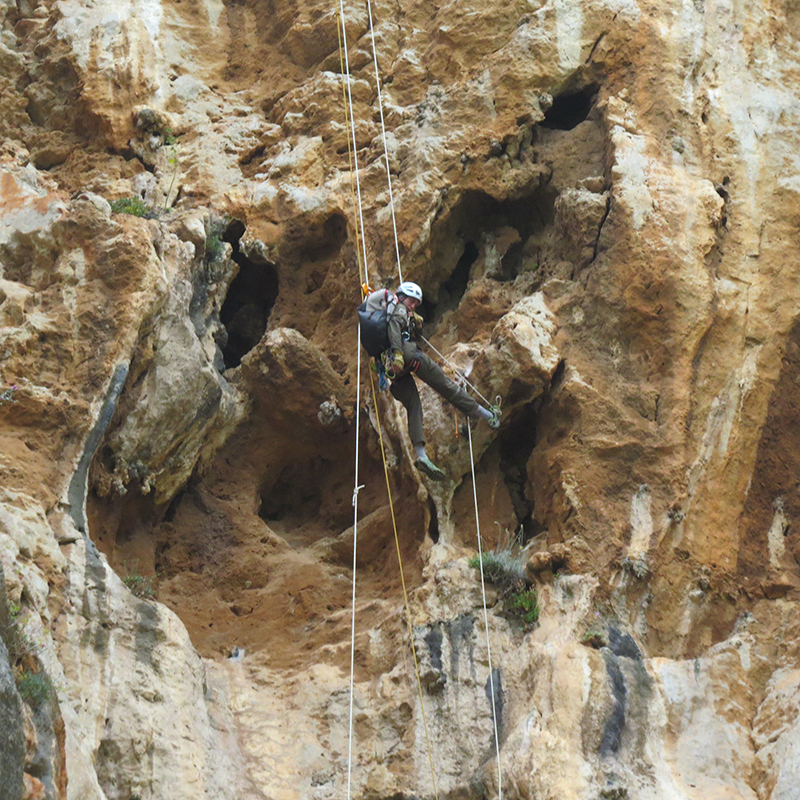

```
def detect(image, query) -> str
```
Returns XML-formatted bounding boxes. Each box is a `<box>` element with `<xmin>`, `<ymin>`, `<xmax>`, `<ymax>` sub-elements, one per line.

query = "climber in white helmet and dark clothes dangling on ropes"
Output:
<box><xmin>359</xmin><ymin>281</ymin><xmax>500</xmax><ymax>481</ymax></box>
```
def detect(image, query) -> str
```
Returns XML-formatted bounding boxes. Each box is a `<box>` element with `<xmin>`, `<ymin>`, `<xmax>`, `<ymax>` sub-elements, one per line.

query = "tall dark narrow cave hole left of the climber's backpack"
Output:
<box><xmin>220</xmin><ymin>220</ymin><xmax>279</xmax><ymax>369</ymax></box>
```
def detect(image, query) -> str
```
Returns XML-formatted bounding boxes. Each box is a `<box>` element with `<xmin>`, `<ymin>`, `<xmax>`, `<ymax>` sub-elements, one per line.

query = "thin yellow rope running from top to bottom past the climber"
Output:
<box><xmin>337</xmin><ymin>3</ymin><xmax>439</xmax><ymax>800</ymax></box>
